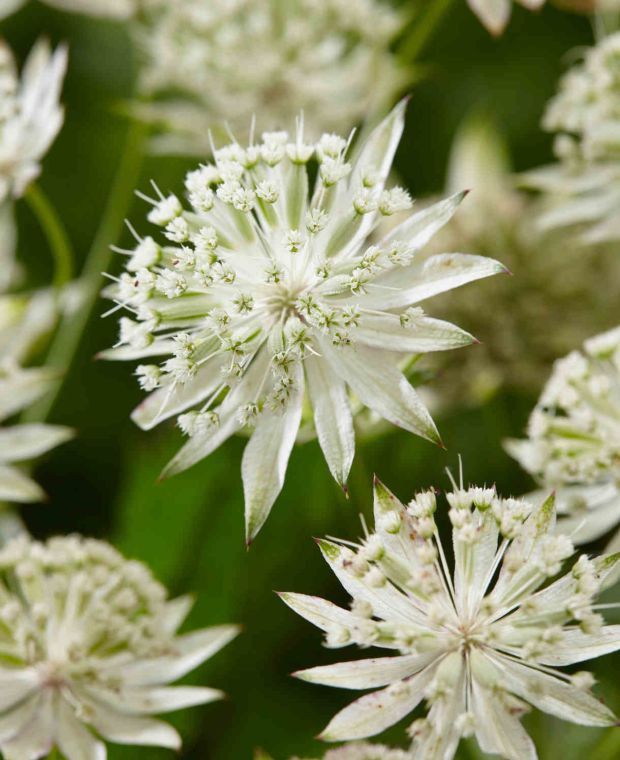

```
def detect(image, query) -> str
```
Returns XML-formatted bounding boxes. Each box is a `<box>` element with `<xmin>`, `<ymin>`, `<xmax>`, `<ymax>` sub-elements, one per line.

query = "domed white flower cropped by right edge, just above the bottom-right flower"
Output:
<box><xmin>507</xmin><ymin>328</ymin><xmax>620</xmax><ymax>543</ymax></box>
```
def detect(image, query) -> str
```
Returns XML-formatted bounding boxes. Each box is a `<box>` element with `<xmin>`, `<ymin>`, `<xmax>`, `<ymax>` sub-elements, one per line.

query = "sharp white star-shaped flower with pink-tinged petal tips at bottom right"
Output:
<box><xmin>281</xmin><ymin>482</ymin><xmax>620</xmax><ymax>760</ymax></box>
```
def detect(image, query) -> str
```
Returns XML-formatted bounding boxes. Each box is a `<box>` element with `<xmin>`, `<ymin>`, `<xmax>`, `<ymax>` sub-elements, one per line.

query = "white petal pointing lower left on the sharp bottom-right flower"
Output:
<box><xmin>319</xmin><ymin>667</ymin><xmax>435</xmax><ymax>741</ymax></box>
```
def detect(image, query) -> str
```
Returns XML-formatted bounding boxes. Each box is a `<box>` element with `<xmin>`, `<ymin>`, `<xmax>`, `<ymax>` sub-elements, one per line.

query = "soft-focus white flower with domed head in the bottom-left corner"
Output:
<box><xmin>0</xmin><ymin>536</ymin><xmax>238</xmax><ymax>760</ymax></box>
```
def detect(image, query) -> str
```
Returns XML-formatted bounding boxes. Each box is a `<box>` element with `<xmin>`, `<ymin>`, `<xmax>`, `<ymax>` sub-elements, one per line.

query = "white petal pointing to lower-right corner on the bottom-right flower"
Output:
<box><xmin>493</xmin><ymin>656</ymin><xmax>616</xmax><ymax>726</ymax></box>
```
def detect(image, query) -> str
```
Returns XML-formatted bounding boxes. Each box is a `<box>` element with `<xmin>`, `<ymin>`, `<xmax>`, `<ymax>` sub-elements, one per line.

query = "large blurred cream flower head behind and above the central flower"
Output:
<box><xmin>136</xmin><ymin>0</ymin><xmax>408</xmax><ymax>156</ymax></box>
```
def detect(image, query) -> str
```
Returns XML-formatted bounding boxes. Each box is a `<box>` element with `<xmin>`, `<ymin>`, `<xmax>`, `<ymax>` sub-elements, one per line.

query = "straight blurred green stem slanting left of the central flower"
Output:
<box><xmin>24</xmin><ymin>121</ymin><xmax>147</xmax><ymax>422</ymax></box>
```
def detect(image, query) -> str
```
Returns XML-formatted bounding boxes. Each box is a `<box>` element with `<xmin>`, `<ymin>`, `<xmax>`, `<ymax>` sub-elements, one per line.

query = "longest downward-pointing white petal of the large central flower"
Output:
<box><xmin>241</xmin><ymin>365</ymin><xmax>304</xmax><ymax>544</ymax></box>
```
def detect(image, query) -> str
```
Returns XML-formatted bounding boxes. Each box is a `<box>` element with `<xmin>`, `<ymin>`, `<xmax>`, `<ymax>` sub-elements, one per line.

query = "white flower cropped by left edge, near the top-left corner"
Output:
<box><xmin>0</xmin><ymin>40</ymin><xmax>67</xmax><ymax>204</ymax></box>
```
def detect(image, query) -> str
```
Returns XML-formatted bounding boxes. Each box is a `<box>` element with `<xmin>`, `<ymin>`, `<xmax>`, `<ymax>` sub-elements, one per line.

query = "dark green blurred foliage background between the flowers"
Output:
<box><xmin>0</xmin><ymin>0</ymin><xmax>620</xmax><ymax>760</ymax></box>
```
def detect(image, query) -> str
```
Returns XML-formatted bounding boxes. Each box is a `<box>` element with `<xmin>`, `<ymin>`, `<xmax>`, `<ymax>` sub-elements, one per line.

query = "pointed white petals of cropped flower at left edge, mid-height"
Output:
<box><xmin>0</xmin><ymin>363</ymin><xmax>73</xmax><ymax>503</ymax></box>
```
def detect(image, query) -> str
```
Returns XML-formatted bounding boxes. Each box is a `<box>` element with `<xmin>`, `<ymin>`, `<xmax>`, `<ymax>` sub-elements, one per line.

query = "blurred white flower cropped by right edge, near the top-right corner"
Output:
<box><xmin>523</xmin><ymin>32</ymin><xmax>620</xmax><ymax>243</ymax></box>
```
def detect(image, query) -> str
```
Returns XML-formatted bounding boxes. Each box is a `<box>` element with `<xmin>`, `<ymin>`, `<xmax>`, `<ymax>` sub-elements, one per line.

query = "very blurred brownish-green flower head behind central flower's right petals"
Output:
<box><xmin>414</xmin><ymin>115</ymin><xmax>620</xmax><ymax>404</ymax></box>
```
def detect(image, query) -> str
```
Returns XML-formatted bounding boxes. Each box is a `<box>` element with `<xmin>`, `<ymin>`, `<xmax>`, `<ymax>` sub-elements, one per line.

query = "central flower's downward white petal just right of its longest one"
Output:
<box><xmin>304</xmin><ymin>356</ymin><xmax>355</xmax><ymax>486</ymax></box>
